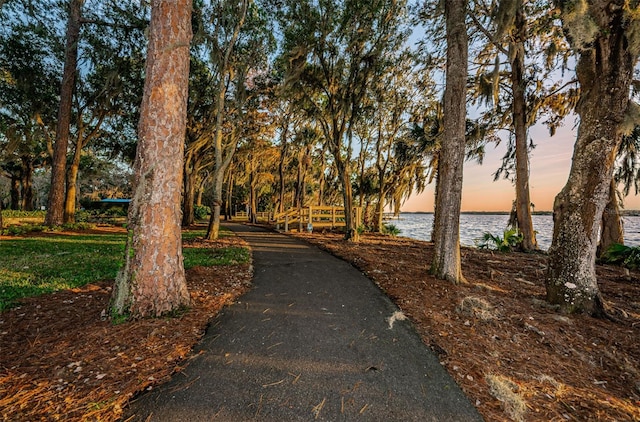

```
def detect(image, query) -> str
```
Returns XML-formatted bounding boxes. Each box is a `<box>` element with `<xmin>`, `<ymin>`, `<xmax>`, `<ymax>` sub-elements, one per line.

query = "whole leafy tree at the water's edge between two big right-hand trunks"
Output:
<box><xmin>469</xmin><ymin>0</ymin><xmax>574</xmax><ymax>251</ymax></box>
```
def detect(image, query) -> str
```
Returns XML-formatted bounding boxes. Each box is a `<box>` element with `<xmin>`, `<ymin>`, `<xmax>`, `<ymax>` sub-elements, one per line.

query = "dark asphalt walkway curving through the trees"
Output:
<box><xmin>127</xmin><ymin>224</ymin><xmax>482</xmax><ymax>422</ymax></box>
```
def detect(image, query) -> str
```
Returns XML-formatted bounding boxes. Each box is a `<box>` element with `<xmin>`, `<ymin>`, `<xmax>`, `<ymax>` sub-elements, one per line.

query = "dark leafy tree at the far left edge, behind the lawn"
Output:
<box><xmin>0</xmin><ymin>23</ymin><xmax>59</xmax><ymax>210</ymax></box>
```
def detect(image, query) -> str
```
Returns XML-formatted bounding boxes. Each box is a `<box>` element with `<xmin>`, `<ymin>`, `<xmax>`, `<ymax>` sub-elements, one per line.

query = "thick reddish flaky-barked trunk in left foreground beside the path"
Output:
<box><xmin>113</xmin><ymin>0</ymin><xmax>191</xmax><ymax>317</ymax></box>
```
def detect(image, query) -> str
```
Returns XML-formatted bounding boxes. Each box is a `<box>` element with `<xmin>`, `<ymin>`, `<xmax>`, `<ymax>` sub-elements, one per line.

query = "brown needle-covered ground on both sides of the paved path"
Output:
<box><xmin>0</xmin><ymin>227</ymin><xmax>640</xmax><ymax>421</ymax></box>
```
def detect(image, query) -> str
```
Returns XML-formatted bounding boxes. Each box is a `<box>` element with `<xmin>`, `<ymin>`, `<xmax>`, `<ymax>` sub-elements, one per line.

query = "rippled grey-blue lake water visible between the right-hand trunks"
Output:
<box><xmin>387</xmin><ymin>213</ymin><xmax>640</xmax><ymax>250</ymax></box>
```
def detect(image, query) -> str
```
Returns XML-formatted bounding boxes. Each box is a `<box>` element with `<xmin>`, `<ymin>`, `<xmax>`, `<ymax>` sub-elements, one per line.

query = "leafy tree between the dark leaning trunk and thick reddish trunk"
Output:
<box><xmin>64</xmin><ymin>1</ymin><xmax>148</xmax><ymax>223</ymax></box>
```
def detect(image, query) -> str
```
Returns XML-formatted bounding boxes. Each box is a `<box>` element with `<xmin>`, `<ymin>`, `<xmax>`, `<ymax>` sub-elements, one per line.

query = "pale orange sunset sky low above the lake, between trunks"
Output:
<box><xmin>401</xmin><ymin>118</ymin><xmax>640</xmax><ymax>212</ymax></box>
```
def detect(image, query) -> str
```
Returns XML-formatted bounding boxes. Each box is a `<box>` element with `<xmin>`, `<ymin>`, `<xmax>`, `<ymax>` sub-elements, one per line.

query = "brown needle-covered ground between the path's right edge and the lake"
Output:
<box><xmin>296</xmin><ymin>234</ymin><xmax>640</xmax><ymax>421</ymax></box>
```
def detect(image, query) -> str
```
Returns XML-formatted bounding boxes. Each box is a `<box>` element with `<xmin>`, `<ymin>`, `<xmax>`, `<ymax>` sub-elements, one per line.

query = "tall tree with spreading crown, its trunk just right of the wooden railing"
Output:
<box><xmin>283</xmin><ymin>0</ymin><xmax>406</xmax><ymax>240</ymax></box>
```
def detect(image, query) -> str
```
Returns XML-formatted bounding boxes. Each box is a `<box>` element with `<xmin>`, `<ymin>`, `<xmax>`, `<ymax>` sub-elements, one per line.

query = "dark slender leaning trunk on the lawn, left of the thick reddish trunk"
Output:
<box><xmin>45</xmin><ymin>0</ymin><xmax>84</xmax><ymax>226</ymax></box>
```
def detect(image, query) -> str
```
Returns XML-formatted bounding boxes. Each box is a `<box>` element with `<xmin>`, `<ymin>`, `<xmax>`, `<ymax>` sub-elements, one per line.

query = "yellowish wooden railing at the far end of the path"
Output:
<box><xmin>272</xmin><ymin>206</ymin><xmax>362</xmax><ymax>231</ymax></box>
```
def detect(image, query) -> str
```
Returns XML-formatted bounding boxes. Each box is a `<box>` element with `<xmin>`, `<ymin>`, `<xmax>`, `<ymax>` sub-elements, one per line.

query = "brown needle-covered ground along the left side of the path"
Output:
<box><xmin>0</xmin><ymin>228</ymin><xmax>252</xmax><ymax>421</ymax></box>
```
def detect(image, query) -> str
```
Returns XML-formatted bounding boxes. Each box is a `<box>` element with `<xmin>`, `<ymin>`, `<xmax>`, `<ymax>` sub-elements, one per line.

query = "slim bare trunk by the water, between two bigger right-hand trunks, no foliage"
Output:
<box><xmin>509</xmin><ymin>0</ymin><xmax>538</xmax><ymax>252</ymax></box>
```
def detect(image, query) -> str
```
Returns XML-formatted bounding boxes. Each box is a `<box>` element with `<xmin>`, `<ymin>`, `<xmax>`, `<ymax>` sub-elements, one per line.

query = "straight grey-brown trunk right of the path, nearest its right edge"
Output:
<box><xmin>430</xmin><ymin>0</ymin><xmax>468</xmax><ymax>283</ymax></box>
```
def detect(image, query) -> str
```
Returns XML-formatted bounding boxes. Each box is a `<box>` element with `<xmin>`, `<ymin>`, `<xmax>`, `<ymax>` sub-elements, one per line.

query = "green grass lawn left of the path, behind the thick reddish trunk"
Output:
<box><xmin>0</xmin><ymin>231</ymin><xmax>249</xmax><ymax>311</ymax></box>
